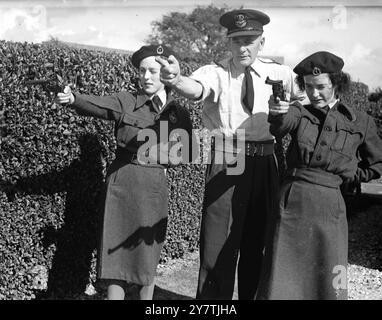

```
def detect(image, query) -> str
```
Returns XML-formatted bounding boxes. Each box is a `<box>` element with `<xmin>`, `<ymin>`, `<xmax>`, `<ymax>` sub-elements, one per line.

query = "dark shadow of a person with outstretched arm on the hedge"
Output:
<box><xmin>11</xmin><ymin>134</ymin><xmax>103</xmax><ymax>299</ymax></box>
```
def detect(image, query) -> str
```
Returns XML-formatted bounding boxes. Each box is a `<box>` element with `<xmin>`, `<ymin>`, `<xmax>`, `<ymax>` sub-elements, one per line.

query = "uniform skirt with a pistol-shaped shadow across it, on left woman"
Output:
<box><xmin>97</xmin><ymin>159</ymin><xmax>168</xmax><ymax>285</ymax></box>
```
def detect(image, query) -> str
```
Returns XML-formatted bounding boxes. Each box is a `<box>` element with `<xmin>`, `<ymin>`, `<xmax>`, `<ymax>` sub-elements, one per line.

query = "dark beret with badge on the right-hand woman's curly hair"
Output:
<box><xmin>293</xmin><ymin>51</ymin><xmax>344</xmax><ymax>76</ymax></box>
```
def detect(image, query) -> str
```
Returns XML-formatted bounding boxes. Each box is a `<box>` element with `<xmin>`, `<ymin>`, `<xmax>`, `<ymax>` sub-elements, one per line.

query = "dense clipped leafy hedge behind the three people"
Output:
<box><xmin>0</xmin><ymin>41</ymin><xmax>382</xmax><ymax>299</ymax></box>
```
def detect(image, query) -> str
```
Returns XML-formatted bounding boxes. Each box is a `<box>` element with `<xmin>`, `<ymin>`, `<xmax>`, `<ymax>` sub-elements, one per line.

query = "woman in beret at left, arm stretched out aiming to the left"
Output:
<box><xmin>56</xmin><ymin>45</ymin><xmax>192</xmax><ymax>300</ymax></box>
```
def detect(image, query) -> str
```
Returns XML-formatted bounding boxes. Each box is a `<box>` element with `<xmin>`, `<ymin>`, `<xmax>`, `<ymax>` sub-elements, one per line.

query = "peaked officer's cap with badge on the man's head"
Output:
<box><xmin>219</xmin><ymin>9</ymin><xmax>271</xmax><ymax>37</ymax></box>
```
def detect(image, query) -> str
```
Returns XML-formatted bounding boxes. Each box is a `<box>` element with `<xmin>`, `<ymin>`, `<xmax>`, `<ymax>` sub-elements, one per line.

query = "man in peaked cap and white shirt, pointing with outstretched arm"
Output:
<box><xmin>157</xmin><ymin>9</ymin><xmax>301</xmax><ymax>299</ymax></box>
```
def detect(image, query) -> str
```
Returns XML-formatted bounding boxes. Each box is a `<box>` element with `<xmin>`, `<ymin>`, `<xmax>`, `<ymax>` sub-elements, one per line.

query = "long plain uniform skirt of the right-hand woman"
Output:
<box><xmin>257</xmin><ymin>171</ymin><xmax>348</xmax><ymax>300</ymax></box>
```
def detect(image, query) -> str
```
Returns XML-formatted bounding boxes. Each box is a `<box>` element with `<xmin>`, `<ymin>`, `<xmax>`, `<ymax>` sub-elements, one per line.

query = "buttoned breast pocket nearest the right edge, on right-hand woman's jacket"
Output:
<box><xmin>331</xmin><ymin>121</ymin><xmax>363</xmax><ymax>158</ymax></box>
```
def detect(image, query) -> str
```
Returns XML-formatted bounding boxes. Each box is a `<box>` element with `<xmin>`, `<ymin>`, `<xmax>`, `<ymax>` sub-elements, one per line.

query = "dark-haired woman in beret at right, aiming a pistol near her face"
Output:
<box><xmin>257</xmin><ymin>51</ymin><xmax>382</xmax><ymax>300</ymax></box>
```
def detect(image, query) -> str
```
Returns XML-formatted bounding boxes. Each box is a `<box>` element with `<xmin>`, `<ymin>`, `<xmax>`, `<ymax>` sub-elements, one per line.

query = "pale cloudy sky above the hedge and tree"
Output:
<box><xmin>0</xmin><ymin>0</ymin><xmax>382</xmax><ymax>90</ymax></box>
